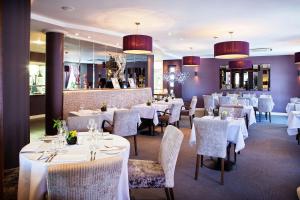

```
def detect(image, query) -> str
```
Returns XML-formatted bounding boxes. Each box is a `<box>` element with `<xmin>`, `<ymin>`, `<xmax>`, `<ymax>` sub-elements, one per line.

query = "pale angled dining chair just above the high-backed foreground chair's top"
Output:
<box><xmin>157</xmin><ymin>103</ymin><xmax>182</xmax><ymax>133</ymax></box>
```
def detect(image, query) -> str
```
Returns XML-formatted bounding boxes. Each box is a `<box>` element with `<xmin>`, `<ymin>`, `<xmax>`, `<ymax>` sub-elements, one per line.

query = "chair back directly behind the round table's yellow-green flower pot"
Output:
<box><xmin>67</xmin><ymin>115</ymin><xmax>102</xmax><ymax>132</ymax></box>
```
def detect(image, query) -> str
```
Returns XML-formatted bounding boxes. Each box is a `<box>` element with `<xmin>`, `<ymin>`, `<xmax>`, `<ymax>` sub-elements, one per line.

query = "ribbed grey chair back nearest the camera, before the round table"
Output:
<box><xmin>47</xmin><ymin>157</ymin><xmax>123</xmax><ymax>200</ymax></box>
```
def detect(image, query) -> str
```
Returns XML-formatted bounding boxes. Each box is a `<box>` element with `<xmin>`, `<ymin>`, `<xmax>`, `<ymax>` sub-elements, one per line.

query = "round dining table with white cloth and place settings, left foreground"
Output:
<box><xmin>18</xmin><ymin>132</ymin><xmax>130</xmax><ymax>200</ymax></box>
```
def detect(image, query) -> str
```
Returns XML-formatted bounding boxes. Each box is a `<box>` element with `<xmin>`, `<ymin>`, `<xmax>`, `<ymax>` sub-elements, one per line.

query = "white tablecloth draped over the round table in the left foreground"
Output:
<box><xmin>18</xmin><ymin>133</ymin><xmax>130</xmax><ymax>200</ymax></box>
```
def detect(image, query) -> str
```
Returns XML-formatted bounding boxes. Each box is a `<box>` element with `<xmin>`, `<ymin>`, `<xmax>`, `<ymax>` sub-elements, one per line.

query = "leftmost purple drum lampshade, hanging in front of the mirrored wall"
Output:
<box><xmin>123</xmin><ymin>35</ymin><xmax>152</xmax><ymax>54</ymax></box>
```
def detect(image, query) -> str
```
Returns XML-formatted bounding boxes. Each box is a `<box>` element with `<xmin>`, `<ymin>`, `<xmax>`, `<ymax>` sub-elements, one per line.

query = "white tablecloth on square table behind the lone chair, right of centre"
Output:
<box><xmin>189</xmin><ymin>116</ymin><xmax>248</xmax><ymax>152</ymax></box>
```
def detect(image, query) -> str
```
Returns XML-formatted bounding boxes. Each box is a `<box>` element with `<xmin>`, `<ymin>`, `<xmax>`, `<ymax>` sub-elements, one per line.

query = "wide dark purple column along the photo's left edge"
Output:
<box><xmin>0</xmin><ymin>0</ymin><xmax>31</xmax><ymax>171</ymax></box>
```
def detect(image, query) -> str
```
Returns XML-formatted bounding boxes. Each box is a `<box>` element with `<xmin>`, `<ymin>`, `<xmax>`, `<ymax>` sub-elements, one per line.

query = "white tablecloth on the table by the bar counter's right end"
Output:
<box><xmin>131</xmin><ymin>103</ymin><xmax>168</xmax><ymax>126</ymax></box>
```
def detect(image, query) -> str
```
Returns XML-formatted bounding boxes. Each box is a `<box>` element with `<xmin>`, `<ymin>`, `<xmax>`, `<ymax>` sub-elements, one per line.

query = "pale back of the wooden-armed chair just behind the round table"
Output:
<box><xmin>112</xmin><ymin>110</ymin><xmax>139</xmax><ymax>136</ymax></box>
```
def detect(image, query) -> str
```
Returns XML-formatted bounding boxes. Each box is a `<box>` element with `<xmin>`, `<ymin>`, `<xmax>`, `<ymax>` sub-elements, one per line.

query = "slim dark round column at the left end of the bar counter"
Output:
<box><xmin>46</xmin><ymin>31</ymin><xmax>64</xmax><ymax>135</ymax></box>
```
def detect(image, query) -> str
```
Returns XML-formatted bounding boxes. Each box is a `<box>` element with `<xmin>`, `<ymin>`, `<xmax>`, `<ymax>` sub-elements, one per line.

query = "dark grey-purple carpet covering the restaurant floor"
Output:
<box><xmin>4</xmin><ymin>116</ymin><xmax>300</xmax><ymax>200</ymax></box>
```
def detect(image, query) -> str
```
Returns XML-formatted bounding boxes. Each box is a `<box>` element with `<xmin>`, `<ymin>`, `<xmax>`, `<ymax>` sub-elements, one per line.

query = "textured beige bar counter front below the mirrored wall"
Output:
<box><xmin>63</xmin><ymin>88</ymin><xmax>152</xmax><ymax>119</ymax></box>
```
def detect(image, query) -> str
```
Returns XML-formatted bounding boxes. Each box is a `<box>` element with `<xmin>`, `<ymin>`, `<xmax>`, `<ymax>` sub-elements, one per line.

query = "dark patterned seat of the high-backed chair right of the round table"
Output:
<box><xmin>128</xmin><ymin>160</ymin><xmax>166</xmax><ymax>189</ymax></box>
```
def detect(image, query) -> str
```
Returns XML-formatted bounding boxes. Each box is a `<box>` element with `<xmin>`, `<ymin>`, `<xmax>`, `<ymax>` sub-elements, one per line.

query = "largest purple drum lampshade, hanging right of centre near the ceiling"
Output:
<box><xmin>214</xmin><ymin>41</ymin><xmax>249</xmax><ymax>59</ymax></box>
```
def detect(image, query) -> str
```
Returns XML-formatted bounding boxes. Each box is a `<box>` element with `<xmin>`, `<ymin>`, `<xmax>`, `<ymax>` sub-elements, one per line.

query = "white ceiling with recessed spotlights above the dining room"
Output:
<box><xmin>31</xmin><ymin>0</ymin><xmax>300</xmax><ymax>59</ymax></box>
